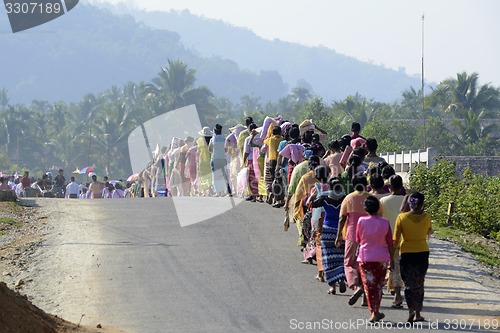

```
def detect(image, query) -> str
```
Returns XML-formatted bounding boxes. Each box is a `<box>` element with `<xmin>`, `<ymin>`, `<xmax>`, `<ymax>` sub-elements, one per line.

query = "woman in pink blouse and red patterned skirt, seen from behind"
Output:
<box><xmin>356</xmin><ymin>196</ymin><xmax>394</xmax><ymax>322</ymax></box>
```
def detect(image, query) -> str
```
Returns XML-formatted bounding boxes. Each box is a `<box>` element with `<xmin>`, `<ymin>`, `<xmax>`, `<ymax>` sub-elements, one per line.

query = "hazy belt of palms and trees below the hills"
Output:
<box><xmin>0</xmin><ymin>66</ymin><xmax>500</xmax><ymax>178</ymax></box>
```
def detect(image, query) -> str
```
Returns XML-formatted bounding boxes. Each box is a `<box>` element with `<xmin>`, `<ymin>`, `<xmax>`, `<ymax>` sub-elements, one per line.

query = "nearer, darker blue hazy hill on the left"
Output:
<box><xmin>0</xmin><ymin>5</ymin><xmax>289</xmax><ymax>103</ymax></box>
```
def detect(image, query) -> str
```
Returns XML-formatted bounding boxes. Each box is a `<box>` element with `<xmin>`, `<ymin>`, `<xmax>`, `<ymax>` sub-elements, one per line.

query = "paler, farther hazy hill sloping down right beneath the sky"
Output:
<box><xmin>103</xmin><ymin>5</ymin><xmax>420</xmax><ymax>102</ymax></box>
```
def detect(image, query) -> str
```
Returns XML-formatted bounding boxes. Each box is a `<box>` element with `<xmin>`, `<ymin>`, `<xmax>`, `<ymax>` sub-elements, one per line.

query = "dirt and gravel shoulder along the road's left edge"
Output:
<box><xmin>0</xmin><ymin>199</ymin><xmax>123</xmax><ymax>333</ymax></box>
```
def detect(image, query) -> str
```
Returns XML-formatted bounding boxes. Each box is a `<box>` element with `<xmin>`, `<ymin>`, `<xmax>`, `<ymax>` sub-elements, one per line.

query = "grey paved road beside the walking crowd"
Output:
<box><xmin>22</xmin><ymin>198</ymin><xmax>498</xmax><ymax>333</ymax></box>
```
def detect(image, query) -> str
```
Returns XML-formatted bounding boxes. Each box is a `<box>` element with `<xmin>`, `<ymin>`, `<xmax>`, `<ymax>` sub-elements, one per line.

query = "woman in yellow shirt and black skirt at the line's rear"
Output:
<box><xmin>394</xmin><ymin>192</ymin><xmax>432</xmax><ymax>322</ymax></box>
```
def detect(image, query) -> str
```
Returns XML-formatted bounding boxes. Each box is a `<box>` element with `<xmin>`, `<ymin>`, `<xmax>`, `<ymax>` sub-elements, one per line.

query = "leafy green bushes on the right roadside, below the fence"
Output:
<box><xmin>409</xmin><ymin>159</ymin><xmax>500</xmax><ymax>266</ymax></box>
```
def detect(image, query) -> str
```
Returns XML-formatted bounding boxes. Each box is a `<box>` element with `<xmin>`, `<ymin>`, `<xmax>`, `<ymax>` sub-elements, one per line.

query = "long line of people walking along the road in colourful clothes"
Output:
<box><xmin>0</xmin><ymin>116</ymin><xmax>432</xmax><ymax>322</ymax></box>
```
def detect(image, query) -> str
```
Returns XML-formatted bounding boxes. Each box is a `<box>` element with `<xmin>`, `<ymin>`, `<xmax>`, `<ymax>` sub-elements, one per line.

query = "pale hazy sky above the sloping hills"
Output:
<box><xmin>88</xmin><ymin>0</ymin><xmax>500</xmax><ymax>87</ymax></box>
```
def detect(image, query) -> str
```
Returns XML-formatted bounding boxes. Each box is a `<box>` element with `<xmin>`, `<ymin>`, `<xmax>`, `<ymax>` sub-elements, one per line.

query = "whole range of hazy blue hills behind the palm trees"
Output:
<box><xmin>0</xmin><ymin>4</ymin><xmax>420</xmax><ymax>103</ymax></box>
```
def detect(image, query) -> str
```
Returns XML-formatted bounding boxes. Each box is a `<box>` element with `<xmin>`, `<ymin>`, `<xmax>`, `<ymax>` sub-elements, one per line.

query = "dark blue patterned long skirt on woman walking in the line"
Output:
<box><xmin>321</xmin><ymin>225</ymin><xmax>345</xmax><ymax>286</ymax></box>
